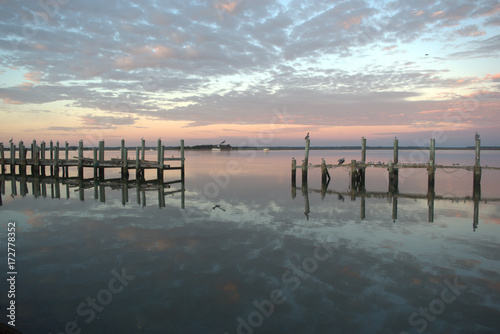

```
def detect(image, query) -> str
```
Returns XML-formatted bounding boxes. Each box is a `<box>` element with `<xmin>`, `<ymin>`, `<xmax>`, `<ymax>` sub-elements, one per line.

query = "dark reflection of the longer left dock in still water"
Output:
<box><xmin>0</xmin><ymin>175</ymin><xmax>185</xmax><ymax>209</ymax></box>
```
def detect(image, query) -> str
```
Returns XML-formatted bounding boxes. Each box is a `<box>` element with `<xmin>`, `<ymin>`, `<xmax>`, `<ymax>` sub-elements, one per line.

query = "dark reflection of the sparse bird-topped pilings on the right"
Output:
<box><xmin>292</xmin><ymin>179</ymin><xmax>490</xmax><ymax>231</ymax></box>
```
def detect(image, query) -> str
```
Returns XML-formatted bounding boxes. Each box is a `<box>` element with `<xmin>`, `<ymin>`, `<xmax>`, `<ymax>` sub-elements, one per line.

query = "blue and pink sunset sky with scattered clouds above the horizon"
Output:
<box><xmin>0</xmin><ymin>0</ymin><xmax>500</xmax><ymax>147</ymax></box>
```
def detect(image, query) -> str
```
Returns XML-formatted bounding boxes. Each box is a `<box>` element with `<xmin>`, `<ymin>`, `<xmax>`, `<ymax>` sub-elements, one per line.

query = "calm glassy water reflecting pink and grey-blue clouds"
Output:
<box><xmin>0</xmin><ymin>151</ymin><xmax>500</xmax><ymax>334</ymax></box>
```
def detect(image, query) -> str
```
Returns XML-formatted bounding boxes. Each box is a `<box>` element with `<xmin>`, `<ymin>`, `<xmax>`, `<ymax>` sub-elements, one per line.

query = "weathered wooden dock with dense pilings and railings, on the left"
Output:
<box><xmin>0</xmin><ymin>139</ymin><xmax>185</xmax><ymax>180</ymax></box>
